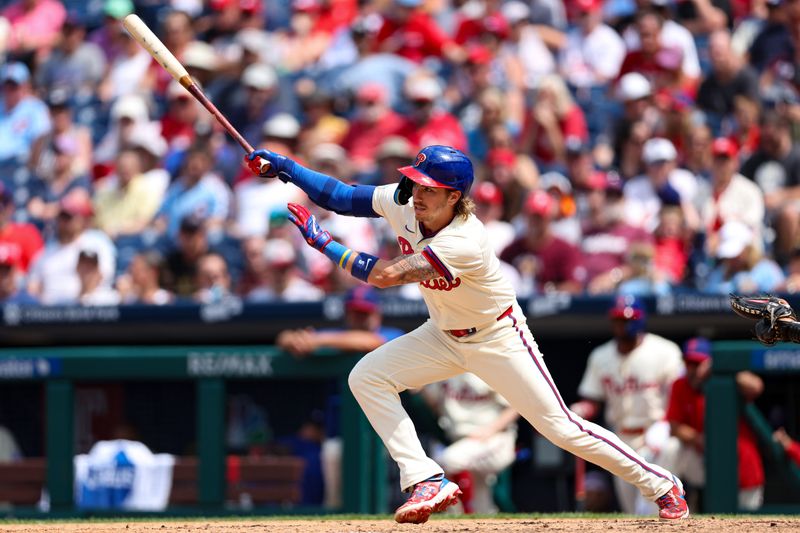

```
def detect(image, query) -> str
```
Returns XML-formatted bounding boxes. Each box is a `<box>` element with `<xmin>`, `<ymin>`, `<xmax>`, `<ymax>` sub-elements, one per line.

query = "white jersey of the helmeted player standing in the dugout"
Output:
<box><xmin>578</xmin><ymin>333</ymin><xmax>684</xmax><ymax>430</ymax></box>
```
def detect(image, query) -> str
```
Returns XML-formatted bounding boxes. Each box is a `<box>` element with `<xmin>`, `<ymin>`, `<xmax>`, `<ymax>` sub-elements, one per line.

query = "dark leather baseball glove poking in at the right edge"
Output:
<box><xmin>730</xmin><ymin>294</ymin><xmax>800</xmax><ymax>346</ymax></box>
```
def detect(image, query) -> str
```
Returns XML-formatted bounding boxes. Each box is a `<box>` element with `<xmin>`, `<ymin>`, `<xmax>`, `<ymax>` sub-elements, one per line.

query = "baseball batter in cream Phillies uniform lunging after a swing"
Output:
<box><xmin>246</xmin><ymin>146</ymin><xmax>689</xmax><ymax>523</ymax></box>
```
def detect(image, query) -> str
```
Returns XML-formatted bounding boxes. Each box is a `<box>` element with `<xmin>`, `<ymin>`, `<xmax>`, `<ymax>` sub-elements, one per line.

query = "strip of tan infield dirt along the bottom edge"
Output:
<box><xmin>0</xmin><ymin>516</ymin><xmax>800</xmax><ymax>533</ymax></box>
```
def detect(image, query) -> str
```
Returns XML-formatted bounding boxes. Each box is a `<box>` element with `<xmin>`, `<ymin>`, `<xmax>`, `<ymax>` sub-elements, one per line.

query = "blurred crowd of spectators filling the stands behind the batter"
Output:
<box><xmin>0</xmin><ymin>0</ymin><xmax>800</xmax><ymax>305</ymax></box>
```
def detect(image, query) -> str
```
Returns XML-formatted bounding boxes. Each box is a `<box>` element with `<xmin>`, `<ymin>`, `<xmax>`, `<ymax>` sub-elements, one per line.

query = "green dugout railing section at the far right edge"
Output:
<box><xmin>703</xmin><ymin>341</ymin><xmax>800</xmax><ymax>514</ymax></box>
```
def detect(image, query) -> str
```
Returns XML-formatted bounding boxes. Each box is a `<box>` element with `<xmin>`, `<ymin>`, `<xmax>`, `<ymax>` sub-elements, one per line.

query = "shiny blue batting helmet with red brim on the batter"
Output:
<box><xmin>397</xmin><ymin>145</ymin><xmax>475</xmax><ymax>196</ymax></box>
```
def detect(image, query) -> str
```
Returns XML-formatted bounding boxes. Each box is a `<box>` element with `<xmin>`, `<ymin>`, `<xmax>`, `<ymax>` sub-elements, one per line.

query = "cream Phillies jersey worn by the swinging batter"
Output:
<box><xmin>372</xmin><ymin>185</ymin><xmax>516</xmax><ymax>330</ymax></box>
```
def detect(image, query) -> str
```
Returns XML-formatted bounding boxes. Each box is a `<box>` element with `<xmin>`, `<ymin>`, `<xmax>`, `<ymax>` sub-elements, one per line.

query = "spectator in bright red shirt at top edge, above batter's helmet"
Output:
<box><xmin>375</xmin><ymin>0</ymin><xmax>464</xmax><ymax>63</ymax></box>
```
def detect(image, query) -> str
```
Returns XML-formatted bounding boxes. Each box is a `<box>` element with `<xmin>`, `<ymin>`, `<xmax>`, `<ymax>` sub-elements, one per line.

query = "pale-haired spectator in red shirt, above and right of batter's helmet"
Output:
<box><xmin>520</xmin><ymin>75</ymin><xmax>589</xmax><ymax>170</ymax></box>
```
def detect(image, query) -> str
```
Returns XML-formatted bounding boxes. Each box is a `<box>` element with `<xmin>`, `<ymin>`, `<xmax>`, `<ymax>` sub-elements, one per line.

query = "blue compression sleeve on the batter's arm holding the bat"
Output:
<box><xmin>278</xmin><ymin>161</ymin><xmax>380</xmax><ymax>218</ymax></box>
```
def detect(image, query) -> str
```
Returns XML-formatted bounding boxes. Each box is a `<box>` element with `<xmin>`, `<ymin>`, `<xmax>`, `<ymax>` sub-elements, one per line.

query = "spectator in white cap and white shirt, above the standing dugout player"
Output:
<box><xmin>623</xmin><ymin>137</ymin><xmax>699</xmax><ymax>232</ymax></box>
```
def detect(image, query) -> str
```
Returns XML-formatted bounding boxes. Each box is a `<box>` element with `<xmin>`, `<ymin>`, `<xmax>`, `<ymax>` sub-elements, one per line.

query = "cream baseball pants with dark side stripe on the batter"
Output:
<box><xmin>349</xmin><ymin>304</ymin><xmax>673</xmax><ymax>500</ymax></box>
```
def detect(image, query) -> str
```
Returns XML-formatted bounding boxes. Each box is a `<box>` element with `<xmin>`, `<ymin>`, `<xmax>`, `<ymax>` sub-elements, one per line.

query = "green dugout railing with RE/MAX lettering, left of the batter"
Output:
<box><xmin>0</xmin><ymin>346</ymin><xmax>387</xmax><ymax>516</ymax></box>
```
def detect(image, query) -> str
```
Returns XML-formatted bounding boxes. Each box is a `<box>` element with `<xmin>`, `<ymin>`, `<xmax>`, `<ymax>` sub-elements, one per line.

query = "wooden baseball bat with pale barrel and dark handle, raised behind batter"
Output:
<box><xmin>122</xmin><ymin>14</ymin><xmax>269</xmax><ymax>172</ymax></box>
